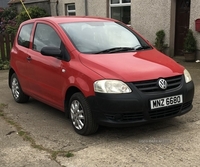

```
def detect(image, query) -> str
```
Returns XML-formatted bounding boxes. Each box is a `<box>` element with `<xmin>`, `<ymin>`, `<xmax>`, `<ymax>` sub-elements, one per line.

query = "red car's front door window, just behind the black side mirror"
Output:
<box><xmin>33</xmin><ymin>23</ymin><xmax>61</xmax><ymax>52</ymax></box>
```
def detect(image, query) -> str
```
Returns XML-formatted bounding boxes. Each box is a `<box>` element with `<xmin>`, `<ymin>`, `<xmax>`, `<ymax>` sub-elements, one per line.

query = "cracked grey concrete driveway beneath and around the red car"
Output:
<box><xmin>0</xmin><ymin>58</ymin><xmax>200</xmax><ymax>167</ymax></box>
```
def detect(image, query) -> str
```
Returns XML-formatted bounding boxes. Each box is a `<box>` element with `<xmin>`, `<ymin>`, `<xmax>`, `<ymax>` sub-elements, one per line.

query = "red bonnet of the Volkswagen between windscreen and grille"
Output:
<box><xmin>80</xmin><ymin>49</ymin><xmax>184</xmax><ymax>82</ymax></box>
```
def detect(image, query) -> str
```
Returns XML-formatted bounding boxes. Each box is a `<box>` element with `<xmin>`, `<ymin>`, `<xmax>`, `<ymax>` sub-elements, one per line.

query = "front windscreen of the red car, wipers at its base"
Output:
<box><xmin>61</xmin><ymin>22</ymin><xmax>150</xmax><ymax>53</ymax></box>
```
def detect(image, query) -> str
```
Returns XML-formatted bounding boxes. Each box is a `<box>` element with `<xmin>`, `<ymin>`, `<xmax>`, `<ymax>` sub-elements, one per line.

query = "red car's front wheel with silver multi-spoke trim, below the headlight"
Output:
<box><xmin>69</xmin><ymin>93</ymin><xmax>98</xmax><ymax>135</ymax></box>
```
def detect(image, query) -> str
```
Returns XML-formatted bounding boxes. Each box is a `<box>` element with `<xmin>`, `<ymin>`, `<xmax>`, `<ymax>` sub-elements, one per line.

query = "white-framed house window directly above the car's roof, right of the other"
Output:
<box><xmin>109</xmin><ymin>0</ymin><xmax>131</xmax><ymax>24</ymax></box>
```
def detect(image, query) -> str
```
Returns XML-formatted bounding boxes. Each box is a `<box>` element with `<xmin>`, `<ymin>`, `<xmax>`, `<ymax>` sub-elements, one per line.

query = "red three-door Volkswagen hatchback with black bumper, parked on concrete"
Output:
<box><xmin>9</xmin><ymin>17</ymin><xmax>194</xmax><ymax>135</ymax></box>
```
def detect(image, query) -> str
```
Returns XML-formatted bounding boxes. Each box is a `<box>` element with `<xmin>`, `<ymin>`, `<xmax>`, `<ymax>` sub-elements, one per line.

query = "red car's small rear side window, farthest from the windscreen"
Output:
<box><xmin>17</xmin><ymin>24</ymin><xmax>33</xmax><ymax>48</ymax></box>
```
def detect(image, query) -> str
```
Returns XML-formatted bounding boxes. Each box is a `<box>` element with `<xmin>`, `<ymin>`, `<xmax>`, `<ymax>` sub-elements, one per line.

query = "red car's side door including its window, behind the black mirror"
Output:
<box><xmin>29</xmin><ymin>23</ymin><xmax>64</xmax><ymax>109</ymax></box>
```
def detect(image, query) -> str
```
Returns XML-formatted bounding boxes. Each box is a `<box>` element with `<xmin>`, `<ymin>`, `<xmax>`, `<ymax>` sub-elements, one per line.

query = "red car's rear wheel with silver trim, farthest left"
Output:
<box><xmin>10</xmin><ymin>73</ymin><xmax>29</xmax><ymax>103</ymax></box>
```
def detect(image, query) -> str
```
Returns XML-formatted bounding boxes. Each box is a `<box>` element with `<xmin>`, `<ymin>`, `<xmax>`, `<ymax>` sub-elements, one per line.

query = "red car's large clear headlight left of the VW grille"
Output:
<box><xmin>94</xmin><ymin>80</ymin><xmax>131</xmax><ymax>93</ymax></box>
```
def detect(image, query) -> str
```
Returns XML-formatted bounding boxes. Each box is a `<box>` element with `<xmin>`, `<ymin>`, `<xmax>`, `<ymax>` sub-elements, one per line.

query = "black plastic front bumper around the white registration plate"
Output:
<box><xmin>88</xmin><ymin>76</ymin><xmax>194</xmax><ymax>127</ymax></box>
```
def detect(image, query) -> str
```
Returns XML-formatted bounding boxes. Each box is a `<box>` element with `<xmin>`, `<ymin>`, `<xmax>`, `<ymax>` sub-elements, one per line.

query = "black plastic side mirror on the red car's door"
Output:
<box><xmin>40</xmin><ymin>47</ymin><xmax>62</xmax><ymax>58</ymax></box>
